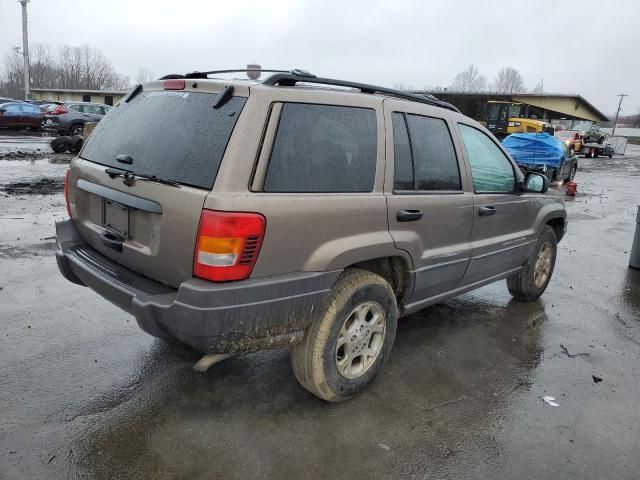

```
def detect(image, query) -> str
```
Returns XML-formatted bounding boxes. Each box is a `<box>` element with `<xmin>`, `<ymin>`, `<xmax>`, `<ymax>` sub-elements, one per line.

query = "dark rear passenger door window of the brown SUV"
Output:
<box><xmin>393</xmin><ymin>113</ymin><xmax>462</xmax><ymax>191</ymax></box>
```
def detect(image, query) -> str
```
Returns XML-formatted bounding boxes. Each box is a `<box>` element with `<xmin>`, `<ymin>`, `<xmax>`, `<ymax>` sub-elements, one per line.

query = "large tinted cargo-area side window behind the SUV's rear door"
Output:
<box><xmin>264</xmin><ymin>103</ymin><xmax>377</xmax><ymax>192</ymax></box>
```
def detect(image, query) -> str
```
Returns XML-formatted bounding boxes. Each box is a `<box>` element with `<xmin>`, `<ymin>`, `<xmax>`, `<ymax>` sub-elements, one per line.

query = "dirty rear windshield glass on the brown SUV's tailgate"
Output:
<box><xmin>82</xmin><ymin>91</ymin><xmax>246</xmax><ymax>189</ymax></box>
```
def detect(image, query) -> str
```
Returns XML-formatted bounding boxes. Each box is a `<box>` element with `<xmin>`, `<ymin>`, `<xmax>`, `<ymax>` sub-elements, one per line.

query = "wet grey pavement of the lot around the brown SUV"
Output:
<box><xmin>0</xmin><ymin>141</ymin><xmax>640</xmax><ymax>479</ymax></box>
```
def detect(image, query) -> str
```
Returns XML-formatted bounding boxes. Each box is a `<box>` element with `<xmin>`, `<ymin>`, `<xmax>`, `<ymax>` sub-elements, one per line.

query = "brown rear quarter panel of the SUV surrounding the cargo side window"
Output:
<box><xmin>205</xmin><ymin>86</ymin><xmax>401</xmax><ymax>277</ymax></box>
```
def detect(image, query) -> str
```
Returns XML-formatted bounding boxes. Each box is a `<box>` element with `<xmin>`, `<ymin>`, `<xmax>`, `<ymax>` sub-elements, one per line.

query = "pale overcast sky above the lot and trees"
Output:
<box><xmin>0</xmin><ymin>0</ymin><xmax>640</xmax><ymax>114</ymax></box>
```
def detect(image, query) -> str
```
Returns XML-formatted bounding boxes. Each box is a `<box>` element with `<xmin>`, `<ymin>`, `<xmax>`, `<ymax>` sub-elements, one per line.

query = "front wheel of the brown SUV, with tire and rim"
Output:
<box><xmin>507</xmin><ymin>225</ymin><xmax>558</xmax><ymax>302</ymax></box>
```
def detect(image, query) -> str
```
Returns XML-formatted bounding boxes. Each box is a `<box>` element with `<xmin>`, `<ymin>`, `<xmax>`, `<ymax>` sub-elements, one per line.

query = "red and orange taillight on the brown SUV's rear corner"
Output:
<box><xmin>193</xmin><ymin>210</ymin><xmax>266</xmax><ymax>282</ymax></box>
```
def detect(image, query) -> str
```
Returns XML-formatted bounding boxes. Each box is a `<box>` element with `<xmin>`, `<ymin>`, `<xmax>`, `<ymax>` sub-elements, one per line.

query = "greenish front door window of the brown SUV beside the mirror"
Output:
<box><xmin>458</xmin><ymin>124</ymin><xmax>516</xmax><ymax>193</ymax></box>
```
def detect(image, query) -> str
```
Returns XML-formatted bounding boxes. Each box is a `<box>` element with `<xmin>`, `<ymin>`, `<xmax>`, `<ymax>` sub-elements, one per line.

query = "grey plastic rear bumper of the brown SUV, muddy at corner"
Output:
<box><xmin>56</xmin><ymin>220</ymin><xmax>340</xmax><ymax>353</ymax></box>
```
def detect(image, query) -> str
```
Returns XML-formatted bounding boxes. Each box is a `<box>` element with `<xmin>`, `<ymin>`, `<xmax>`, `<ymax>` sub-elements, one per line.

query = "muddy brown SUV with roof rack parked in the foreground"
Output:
<box><xmin>56</xmin><ymin>70</ymin><xmax>566</xmax><ymax>401</ymax></box>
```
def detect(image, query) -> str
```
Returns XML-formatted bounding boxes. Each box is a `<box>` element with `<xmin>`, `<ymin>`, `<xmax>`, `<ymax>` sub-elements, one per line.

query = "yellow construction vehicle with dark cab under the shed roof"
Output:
<box><xmin>485</xmin><ymin>100</ymin><xmax>553</xmax><ymax>138</ymax></box>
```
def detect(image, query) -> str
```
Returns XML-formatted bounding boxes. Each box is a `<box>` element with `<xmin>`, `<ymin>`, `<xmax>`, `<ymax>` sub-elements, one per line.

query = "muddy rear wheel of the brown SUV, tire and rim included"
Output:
<box><xmin>291</xmin><ymin>269</ymin><xmax>398</xmax><ymax>402</ymax></box>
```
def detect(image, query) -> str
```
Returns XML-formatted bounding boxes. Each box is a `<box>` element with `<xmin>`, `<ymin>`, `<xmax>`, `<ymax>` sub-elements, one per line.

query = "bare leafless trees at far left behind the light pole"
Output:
<box><xmin>0</xmin><ymin>43</ymin><xmax>129</xmax><ymax>98</ymax></box>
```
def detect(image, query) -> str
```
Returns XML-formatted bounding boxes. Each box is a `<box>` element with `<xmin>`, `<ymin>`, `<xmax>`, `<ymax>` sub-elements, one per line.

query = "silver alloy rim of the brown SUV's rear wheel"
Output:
<box><xmin>336</xmin><ymin>302</ymin><xmax>386</xmax><ymax>379</ymax></box>
